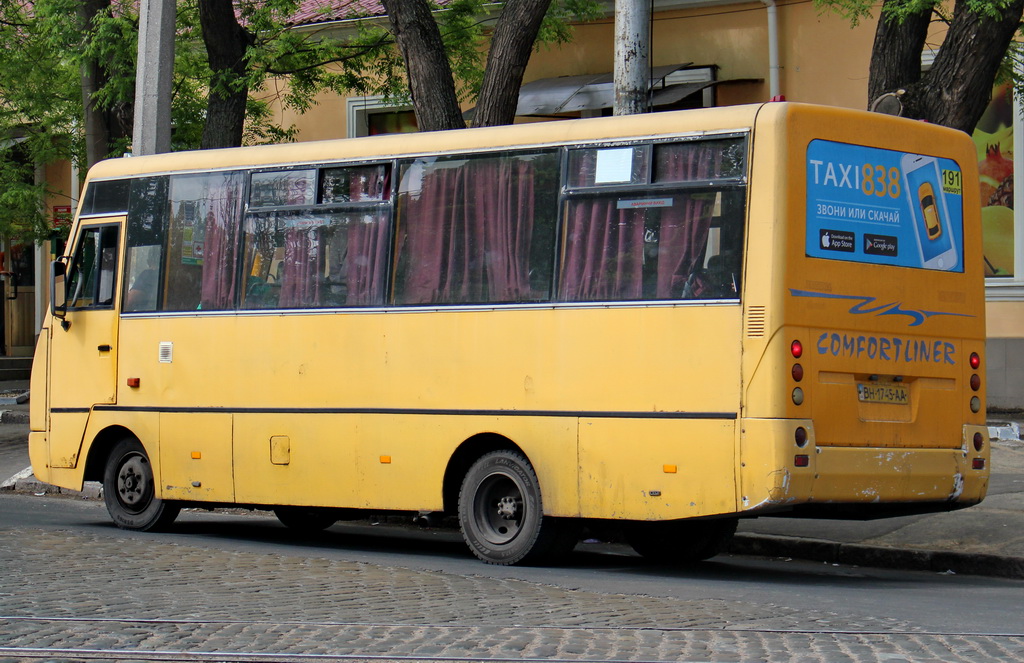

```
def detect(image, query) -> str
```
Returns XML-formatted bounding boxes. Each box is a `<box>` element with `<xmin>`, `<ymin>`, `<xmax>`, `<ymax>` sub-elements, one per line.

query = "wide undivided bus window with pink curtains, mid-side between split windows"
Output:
<box><xmin>395</xmin><ymin>157</ymin><xmax>537</xmax><ymax>304</ymax></box>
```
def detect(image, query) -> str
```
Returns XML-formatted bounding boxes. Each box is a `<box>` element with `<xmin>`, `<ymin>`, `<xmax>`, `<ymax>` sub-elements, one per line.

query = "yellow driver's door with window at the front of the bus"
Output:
<box><xmin>48</xmin><ymin>216</ymin><xmax>124</xmax><ymax>467</ymax></box>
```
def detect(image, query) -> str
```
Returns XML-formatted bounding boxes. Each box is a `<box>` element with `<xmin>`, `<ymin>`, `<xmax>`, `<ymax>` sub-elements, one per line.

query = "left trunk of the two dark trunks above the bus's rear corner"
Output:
<box><xmin>867</xmin><ymin>0</ymin><xmax>932</xmax><ymax>108</ymax></box>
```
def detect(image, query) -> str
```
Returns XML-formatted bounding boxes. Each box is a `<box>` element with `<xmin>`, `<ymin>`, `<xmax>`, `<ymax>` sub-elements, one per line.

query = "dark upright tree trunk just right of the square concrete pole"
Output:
<box><xmin>199</xmin><ymin>0</ymin><xmax>253</xmax><ymax>150</ymax></box>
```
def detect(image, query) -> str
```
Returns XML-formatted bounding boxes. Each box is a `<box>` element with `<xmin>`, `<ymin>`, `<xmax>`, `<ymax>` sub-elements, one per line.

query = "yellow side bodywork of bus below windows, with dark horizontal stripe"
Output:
<box><xmin>117</xmin><ymin>304</ymin><xmax>739</xmax><ymax>519</ymax></box>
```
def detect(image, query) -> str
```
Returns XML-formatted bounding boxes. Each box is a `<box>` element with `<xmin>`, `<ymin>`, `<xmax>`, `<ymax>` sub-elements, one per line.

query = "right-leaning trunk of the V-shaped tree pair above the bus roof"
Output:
<box><xmin>473</xmin><ymin>0</ymin><xmax>551</xmax><ymax>127</ymax></box>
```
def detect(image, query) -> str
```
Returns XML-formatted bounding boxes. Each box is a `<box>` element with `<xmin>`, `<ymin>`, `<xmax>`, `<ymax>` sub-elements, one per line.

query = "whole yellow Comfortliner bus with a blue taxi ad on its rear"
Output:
<box><xmin>30</xmin><ymin>102</ymin><xmax>989</xmax><ymax>564</ymax></box>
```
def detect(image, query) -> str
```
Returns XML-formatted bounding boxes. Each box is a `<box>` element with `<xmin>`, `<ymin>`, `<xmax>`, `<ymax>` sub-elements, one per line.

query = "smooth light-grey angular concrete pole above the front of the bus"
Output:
<box><xmin>132</xmin><ymin>0</ymin><xmax>175</xmax><ymax>156</ymax></box>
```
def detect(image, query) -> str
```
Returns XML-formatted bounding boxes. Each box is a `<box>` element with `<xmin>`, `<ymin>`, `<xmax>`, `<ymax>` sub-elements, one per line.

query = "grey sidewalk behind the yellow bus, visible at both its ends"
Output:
<box><xmin>0</xmin><ymin>383</ymin><xmax>1024</xmax><ymax>578</ymax></box>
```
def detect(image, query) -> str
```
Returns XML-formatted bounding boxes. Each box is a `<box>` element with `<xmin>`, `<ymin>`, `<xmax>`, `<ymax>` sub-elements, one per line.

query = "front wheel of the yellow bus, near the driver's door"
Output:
<box><xmin>103</xmin><ymin>438</ymin><xmax>181</xmax><ymax>532</ymax></box>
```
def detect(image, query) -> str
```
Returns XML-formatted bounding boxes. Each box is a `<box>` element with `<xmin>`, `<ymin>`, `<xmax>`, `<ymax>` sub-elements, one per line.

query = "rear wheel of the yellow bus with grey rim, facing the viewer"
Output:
<box><xmin>459</xmin><ymin>450</ymin><xmax>579</xmax><ymax>566</ymax></box>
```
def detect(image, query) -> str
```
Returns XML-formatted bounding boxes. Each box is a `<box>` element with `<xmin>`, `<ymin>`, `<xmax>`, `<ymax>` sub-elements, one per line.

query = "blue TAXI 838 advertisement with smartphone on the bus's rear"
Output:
<box><xmin>806</xmin><ymin>140</ymin><xmax>964</xmax><ymax>272</ymax></box>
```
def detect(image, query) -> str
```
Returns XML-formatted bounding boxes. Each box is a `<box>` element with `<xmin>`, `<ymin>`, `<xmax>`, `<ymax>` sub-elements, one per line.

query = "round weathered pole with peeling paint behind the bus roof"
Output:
<box><xmin>612</xmin><ymin>0</ymin><xmax>650</xmax><ymax>115</ymax></box>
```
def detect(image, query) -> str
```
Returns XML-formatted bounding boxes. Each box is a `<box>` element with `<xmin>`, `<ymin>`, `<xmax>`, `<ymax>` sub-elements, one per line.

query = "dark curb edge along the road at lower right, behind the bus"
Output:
<box><xmin>725</xmin><ymin>534</ymin><xmax>1024</xmax><ymax>579</ymax></box>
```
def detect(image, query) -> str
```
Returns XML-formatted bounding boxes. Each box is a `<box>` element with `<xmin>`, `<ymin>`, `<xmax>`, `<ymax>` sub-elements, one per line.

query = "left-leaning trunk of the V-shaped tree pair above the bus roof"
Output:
<box><xmin>383</xmin><ymin>0</ymin><xmax>466</xmax><ymax>131</ymax></box>
